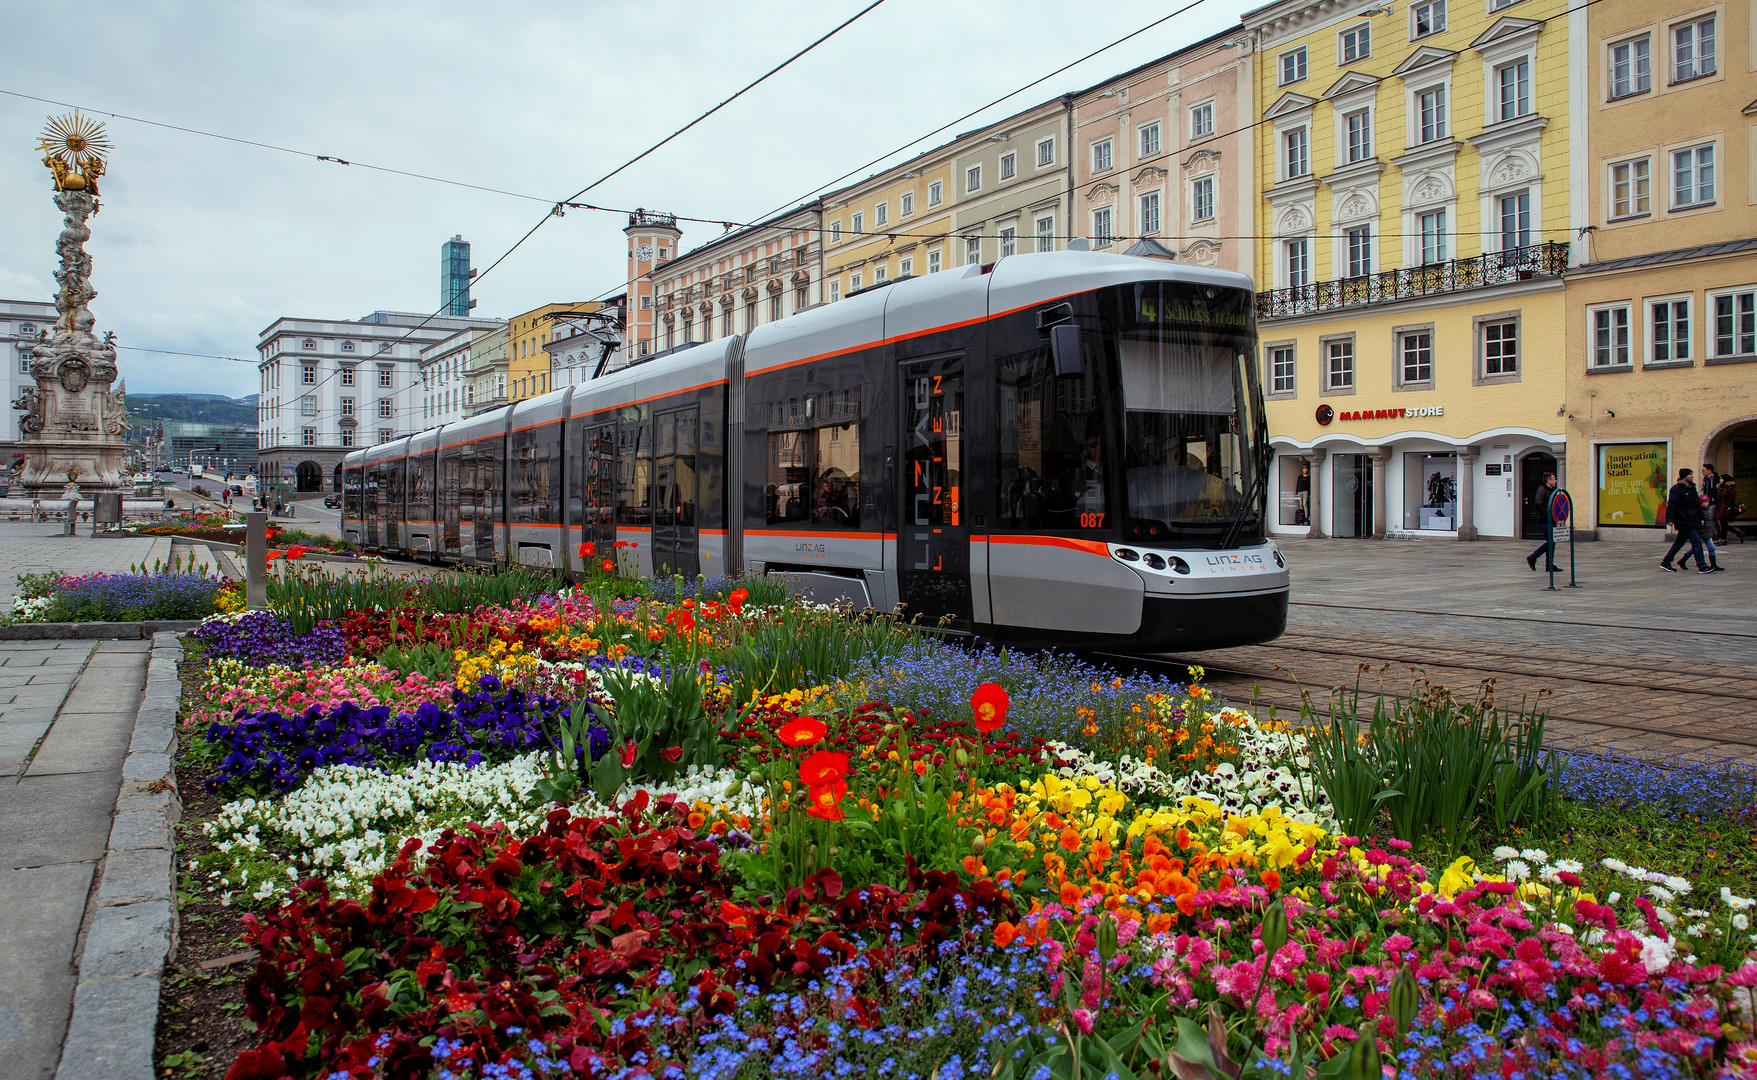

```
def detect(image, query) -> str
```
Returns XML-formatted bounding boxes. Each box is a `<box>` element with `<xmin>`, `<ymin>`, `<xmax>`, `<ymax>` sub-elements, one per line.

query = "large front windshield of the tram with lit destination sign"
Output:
<box><xmin>1116</xmin><ymin>281</ymin><xmax>1263</xmax><ymax>546</ymax></box>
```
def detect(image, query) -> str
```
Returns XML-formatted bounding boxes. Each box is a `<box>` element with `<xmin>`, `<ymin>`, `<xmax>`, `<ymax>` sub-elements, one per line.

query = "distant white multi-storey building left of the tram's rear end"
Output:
<box><xmin>257</xmin><ymin>311</ymin><xmax>506</xmax><ymax>492</ymax></box>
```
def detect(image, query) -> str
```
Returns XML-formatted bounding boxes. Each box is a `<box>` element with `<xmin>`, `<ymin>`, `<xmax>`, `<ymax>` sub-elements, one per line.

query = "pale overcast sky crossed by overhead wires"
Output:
<box><xmin>0</xmin><ymin>0</ymin><xmax>1256</xmax><ymax>397</ymax></box>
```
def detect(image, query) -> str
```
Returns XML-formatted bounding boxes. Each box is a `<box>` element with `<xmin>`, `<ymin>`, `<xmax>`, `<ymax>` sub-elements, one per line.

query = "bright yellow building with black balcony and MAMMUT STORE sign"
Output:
<box><xmin>1244</xmin><ymin>0</ymin><xmax>1571</xmax><ymax>539</ymax></box>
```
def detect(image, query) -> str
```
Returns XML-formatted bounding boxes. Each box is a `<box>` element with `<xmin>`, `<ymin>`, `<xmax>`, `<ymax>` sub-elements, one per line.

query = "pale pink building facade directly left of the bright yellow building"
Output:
<box><xmin>1068</xmin><ymin>26</ymin><xmax>1256</xmax><ymax>274</ymax></box>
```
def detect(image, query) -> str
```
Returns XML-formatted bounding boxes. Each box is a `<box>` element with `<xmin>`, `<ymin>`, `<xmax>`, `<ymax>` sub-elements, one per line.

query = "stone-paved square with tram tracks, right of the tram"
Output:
<box><xmin>1138</xmin><ymin>541</ymin><xmax>1757</xmax><ymax>764</ymax></box>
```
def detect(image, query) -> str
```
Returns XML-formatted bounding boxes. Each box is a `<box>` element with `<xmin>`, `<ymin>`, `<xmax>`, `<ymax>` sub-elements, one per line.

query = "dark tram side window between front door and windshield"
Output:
<box><xmin>994</xmin><ymin>348</ymin><xmax>1110</xmax><ymax>529</ymax></box>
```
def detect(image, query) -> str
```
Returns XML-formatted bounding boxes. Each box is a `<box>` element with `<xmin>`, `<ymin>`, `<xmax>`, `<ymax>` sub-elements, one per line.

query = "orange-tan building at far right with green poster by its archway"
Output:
<box><xmin>1567</xmin><ymin>0</ymin><xmax>1757</xmax><ymax>541</ymax></box>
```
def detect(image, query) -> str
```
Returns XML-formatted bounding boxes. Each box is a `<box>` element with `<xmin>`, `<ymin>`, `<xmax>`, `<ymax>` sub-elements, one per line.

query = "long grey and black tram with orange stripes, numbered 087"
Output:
<box><xmin>343</xmin><ymin>251</ymin><xmax>1290</xmax><ymax>652</ymax></box>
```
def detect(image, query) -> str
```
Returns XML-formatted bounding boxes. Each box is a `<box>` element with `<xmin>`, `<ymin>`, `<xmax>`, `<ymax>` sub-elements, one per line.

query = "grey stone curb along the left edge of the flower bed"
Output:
<box><xmin>54</xmin><ymin>623</ymin><xmax>183</xmax><ymax>1080</ymax></box>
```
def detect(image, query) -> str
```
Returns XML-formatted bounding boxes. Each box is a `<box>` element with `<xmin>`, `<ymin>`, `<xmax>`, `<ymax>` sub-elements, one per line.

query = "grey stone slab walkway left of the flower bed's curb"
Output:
<box><xmin>0</xmin><ymin>642</ymin><xmax>151</xmax><ymax>1080</ymax></box>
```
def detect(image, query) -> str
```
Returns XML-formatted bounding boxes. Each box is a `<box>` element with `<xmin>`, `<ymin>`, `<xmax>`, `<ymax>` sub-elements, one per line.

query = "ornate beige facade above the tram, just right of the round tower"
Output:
<box><xmin>653</xmin><ymin>202</ymin><xmax>822</xmax><ymax>351</ymax></box>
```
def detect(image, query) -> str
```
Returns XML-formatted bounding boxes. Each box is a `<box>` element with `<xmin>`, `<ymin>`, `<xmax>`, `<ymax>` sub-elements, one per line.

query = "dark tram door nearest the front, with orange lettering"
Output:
<box><xmin>896</xmin><ymin>358</ymin><xmax>970</xmax><ymax>625</ymax></box>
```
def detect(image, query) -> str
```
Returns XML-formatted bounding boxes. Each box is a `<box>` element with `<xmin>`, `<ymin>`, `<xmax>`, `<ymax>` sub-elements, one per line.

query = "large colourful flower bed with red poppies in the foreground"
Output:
<box><xmin>167</xmin><ymin>583</ymin><xmax>1757</xmax><ymax>1080</ymax></box>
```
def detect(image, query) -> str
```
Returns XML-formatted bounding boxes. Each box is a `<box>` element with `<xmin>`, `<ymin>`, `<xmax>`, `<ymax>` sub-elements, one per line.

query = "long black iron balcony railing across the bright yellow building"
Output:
<box><xmin>1256</xmin><ymin>244</ymin><xmax>1567</xmax><ymax>320</ymax></box>
